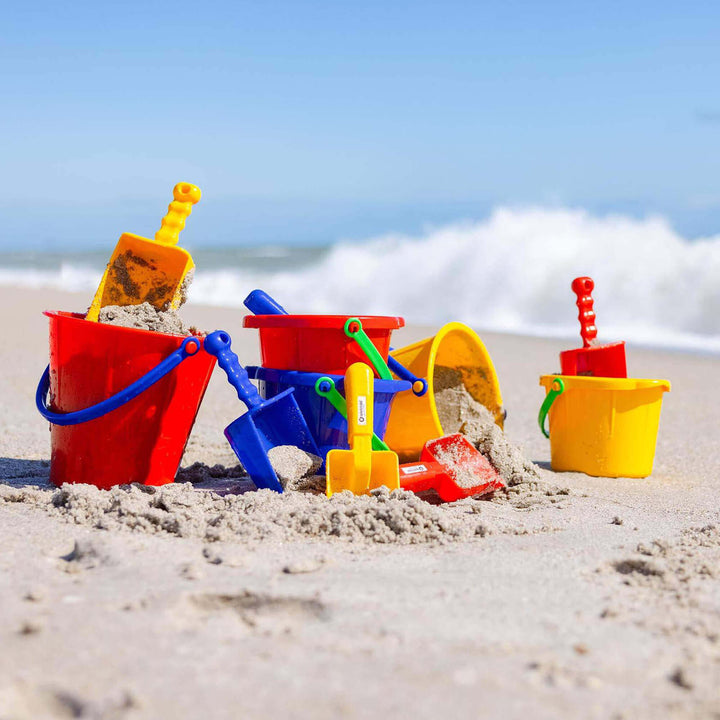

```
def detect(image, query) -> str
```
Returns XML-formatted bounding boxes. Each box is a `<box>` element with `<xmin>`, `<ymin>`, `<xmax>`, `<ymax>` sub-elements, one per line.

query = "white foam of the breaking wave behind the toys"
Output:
<box><xmin>0</xmin><ymin>208</ymin><xmax>720</xmax><ymax>351</ymax></box>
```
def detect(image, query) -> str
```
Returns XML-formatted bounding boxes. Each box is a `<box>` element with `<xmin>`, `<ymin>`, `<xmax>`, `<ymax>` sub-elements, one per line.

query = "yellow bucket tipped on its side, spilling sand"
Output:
<box><xmin>385</xmin><ymin>322</ymin><xmax>505</xmax><ymax>461</ymax></box>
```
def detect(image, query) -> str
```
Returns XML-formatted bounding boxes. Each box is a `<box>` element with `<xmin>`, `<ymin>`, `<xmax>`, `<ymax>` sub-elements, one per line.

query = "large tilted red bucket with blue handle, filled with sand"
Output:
<box><xmin>38</xmin><ymin>312</ymin><xmax>215</xmax><ymax>489</ymax></box>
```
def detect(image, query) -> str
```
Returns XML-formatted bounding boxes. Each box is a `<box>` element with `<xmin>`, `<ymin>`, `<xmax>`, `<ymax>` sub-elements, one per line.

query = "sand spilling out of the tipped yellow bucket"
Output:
<box><xmin>433</xmin><ymin>366</ymin><xmax>540</xmax><ymax>486</ymax></box>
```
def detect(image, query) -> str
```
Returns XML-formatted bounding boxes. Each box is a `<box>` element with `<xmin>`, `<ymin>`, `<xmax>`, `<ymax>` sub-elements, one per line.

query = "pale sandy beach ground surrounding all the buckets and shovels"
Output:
<box><xmin>0</xmin><ymin>288</ymin><xmax>720</xmax><ymax>720</ymax></box>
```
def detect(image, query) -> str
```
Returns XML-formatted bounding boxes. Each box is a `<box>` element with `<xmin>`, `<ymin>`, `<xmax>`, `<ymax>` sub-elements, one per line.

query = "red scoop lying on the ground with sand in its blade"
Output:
<box><xmin>400</xmin><ymin>433</ymin><xmax>505</xmax><ymax>502</ymax></box>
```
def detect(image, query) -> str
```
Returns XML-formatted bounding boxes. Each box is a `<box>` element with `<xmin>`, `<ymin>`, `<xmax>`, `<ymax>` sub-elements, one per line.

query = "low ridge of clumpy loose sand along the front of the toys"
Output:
<box><xmin>0</xmin><ymin>483</ymin><xmax>487</xmax><ymax>544</ymax></box>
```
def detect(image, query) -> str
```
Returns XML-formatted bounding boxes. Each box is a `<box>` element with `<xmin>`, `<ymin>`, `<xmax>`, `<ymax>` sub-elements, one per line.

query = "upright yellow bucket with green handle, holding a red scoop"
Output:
<box><xmin>538</xmin><ymin>375</ymin><xmax>670</xmax><ymax>477</ymax></box>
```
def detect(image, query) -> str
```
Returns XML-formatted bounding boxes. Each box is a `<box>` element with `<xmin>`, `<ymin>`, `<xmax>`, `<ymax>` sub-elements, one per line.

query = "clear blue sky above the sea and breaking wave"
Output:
<box><xmin>0</xmin><ymin>0</ymin><xmax>720</xmax><ymax>249</ymax></box>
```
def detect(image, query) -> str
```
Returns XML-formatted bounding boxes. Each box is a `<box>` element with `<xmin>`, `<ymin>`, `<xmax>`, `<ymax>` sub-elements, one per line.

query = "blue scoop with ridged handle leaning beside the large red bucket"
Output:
<box><xmin>203</xmin><ymin>330</ymin><xmax>320</xmax><ymax>492</ymax></box>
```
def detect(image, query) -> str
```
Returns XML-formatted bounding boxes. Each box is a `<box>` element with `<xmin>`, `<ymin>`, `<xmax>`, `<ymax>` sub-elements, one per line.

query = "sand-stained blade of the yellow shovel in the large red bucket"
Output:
<box><xmin>87</xmin><ymin>233</ymin><xmax>194</xmax><ymax>320</ymax></box>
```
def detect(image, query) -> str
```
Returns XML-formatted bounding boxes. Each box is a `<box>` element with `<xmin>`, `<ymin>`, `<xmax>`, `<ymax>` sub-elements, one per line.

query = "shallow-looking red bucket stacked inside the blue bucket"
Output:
<box><xmin>243</xmin><ymin>315</ymin><xmax>405</xmax><ymax>375</ymax></box>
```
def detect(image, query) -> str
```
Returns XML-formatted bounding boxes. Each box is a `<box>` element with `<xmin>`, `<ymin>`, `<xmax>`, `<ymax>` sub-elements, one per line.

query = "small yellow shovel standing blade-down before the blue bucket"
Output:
<box><xmin>325</xmin><ymin>363</ymin><xmax>400</xmax><ymax>497</ymax></box>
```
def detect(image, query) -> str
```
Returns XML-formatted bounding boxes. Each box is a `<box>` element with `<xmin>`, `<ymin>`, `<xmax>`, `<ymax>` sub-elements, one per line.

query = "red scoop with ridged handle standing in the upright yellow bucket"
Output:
<box><xmin>560</xmin><ymin>277</ymin><xmax>627</xmax><ymax>377</ymax></box>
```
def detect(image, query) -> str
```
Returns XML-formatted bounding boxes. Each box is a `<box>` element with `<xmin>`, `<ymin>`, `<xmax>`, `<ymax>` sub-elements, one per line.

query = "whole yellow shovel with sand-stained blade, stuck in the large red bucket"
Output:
<box><xmin>85</xmin><ymin>183</ymin><xmax>200</xmax><ymax>322</ymax></box>
